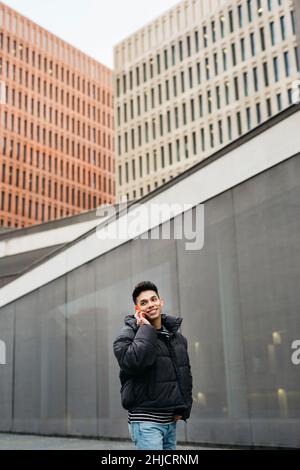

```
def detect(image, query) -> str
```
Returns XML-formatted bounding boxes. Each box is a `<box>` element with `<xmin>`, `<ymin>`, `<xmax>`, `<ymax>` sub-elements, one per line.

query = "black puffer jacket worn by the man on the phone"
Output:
<box><xmin>113</xmin><ymin>314</ymin><xmax>192</xmax><ymax>420</ymax></box>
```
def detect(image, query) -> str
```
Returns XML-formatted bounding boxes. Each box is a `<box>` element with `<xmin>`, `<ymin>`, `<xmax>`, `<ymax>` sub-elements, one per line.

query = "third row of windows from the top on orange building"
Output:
<box><xmin>0</xmin><ymin>57</ymin><xmax>113</xmax><ymax>120</ymax></box>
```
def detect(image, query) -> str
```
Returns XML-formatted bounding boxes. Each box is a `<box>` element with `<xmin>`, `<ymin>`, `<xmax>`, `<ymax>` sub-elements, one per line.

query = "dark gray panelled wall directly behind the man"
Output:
<box><xmin>0</xmin><ymin>155</ymin><xmax>300</xmax><ymax>447</ymax></box>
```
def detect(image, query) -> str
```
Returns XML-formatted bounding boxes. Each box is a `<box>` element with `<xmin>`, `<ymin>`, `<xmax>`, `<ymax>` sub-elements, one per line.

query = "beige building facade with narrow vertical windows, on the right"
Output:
<box><xmin>114</xmin><ymin>0</ymin><xmax>300</xmax><ymax>201</ymax></box>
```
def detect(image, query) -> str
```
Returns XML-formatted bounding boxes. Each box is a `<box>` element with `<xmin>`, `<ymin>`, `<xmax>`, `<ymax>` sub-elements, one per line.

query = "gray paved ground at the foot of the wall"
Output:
<box><xmin>0</xmin><ymin>433</ymin><xmax>220</xmax><ymax>450</ymax></box>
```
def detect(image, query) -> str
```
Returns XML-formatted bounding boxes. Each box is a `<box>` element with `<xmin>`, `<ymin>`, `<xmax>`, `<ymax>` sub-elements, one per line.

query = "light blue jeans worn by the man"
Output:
<box><xmin>128</xmin><ymin>421</ymin><xmax>176</xmax><ymax>450</ymax></box>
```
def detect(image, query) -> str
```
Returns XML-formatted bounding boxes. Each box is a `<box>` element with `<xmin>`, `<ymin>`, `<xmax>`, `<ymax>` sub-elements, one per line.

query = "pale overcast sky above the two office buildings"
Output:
<box><xmin>3</xmin><ymin>0</ymin><xmax>179</xmax><ymax>67</ymax></box>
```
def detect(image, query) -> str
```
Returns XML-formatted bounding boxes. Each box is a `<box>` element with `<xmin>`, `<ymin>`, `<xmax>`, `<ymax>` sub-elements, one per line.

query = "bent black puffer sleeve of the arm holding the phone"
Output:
<box><xmin>113</xmin><ymin>325</ymin><xmax>157</xmax><ymax>375</ymax></box>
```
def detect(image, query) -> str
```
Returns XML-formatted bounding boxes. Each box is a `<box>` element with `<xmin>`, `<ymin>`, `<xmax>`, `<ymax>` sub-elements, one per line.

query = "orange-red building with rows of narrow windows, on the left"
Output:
<box><xmin>0</xmin><ymin>2</ymin><xmax>115</xmax><ymax>227</ymax></box>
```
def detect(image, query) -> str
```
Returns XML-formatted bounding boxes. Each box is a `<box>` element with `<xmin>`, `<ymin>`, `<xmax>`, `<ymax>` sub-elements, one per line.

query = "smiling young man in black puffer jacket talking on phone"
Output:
<box><xmin>113</xmin><ymin>281</ymin><xmax>192</xmax><ymax>450</ymax></box>
